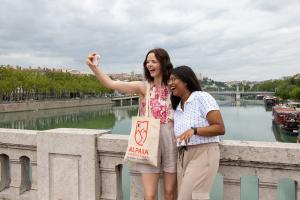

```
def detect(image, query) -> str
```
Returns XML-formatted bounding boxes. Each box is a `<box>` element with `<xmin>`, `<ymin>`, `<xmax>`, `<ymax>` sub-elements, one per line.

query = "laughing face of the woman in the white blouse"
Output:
<box><xmin>168</xmin><ymin>74</ymin><xmax>190</xmax><ymax>98</ymax></box>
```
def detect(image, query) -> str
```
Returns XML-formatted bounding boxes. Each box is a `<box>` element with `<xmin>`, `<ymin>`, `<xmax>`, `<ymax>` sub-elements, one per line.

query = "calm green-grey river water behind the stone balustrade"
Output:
<box><xmin>0</xmin><ymin>101</ymin><xmax>296</xmax><ymax>199</ymax></box>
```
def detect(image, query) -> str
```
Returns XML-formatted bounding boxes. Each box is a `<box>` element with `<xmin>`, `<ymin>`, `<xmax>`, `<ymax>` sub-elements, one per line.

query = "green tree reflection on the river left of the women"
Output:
<box><xmin>0</xmin><ymin>105</ymin><xmax>137</xmax><ymax>130</ymax></box>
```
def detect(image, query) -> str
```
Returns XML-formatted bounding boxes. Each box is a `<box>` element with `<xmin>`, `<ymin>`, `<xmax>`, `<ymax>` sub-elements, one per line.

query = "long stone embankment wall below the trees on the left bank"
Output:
<box><xmin>0</xmin><ymin>98</ymin><xmax>113</xmax><ymax>113</ymax></box>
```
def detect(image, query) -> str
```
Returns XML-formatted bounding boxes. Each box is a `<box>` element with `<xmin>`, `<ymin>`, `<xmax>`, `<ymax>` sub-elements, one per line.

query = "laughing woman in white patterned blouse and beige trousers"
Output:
<box><xmin>168</xmin><ymin>66</ymin><xmax>225</xmax><ymax>200</ymax></box>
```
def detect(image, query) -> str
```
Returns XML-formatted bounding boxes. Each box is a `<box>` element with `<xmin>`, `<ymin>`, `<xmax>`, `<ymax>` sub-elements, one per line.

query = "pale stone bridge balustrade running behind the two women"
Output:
<box><xmin>0</xmin><ymin>129</ymin><xmax>300</xmax><ymax>200</ymax></box>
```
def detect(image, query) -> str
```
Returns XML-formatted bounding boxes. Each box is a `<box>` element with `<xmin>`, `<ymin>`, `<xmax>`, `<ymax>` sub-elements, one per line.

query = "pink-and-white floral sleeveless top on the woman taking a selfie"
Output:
<box><xmin>140</xmin><ymin>83</ymin><xmax>174</xmax><ymax>124</ymax></box>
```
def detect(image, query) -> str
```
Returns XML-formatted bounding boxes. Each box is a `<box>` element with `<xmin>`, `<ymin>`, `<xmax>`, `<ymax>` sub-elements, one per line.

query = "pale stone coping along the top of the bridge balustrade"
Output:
<box><xmin>0</xmin><ymin>128</ymin><xmax>300</xmax><ymax>167</ymax></box>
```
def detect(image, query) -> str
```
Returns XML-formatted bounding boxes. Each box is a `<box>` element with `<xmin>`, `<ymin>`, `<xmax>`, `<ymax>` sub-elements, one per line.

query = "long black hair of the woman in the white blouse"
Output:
<box><xmin>171</xmin><ymin>65</ymin><xmax>202</xmax><ymax>110</ymax></box>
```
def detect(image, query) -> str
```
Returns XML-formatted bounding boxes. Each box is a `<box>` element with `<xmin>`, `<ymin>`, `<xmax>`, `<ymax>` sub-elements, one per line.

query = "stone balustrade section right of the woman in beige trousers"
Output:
<box><xmin>219</xmin><ymin>140</ymin><xmax>300</xmax><ymax>200</ymax></box>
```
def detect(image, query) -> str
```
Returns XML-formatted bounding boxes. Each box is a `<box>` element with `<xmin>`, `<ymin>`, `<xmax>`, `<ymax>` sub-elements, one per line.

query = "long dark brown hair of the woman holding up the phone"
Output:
<box><xmin>143</xmin><ymin>48</ymin><xmax>173</xmax><ymax>85</ymax></box>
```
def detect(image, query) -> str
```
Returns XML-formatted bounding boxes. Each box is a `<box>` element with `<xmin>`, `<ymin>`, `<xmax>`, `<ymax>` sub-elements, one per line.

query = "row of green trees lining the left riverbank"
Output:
<box><xmin>0</xmin><ymin>65</ymin><xmax>113</xmax><ymax>101</ymax></box>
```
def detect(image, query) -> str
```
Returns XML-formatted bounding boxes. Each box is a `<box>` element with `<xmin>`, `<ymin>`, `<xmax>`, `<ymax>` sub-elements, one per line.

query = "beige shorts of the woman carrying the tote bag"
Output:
<box><xmin>131</xmin><ymin>123</ymin><xmax>177</xmax><ymax>173</ymax></box>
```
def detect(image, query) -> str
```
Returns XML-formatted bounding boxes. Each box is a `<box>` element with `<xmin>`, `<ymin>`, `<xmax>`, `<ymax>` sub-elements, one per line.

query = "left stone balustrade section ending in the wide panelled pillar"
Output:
<box><xmin>0</xmin><ymin>128</ymin><xmax>110</xmax><ymax>200</ymax></box>
